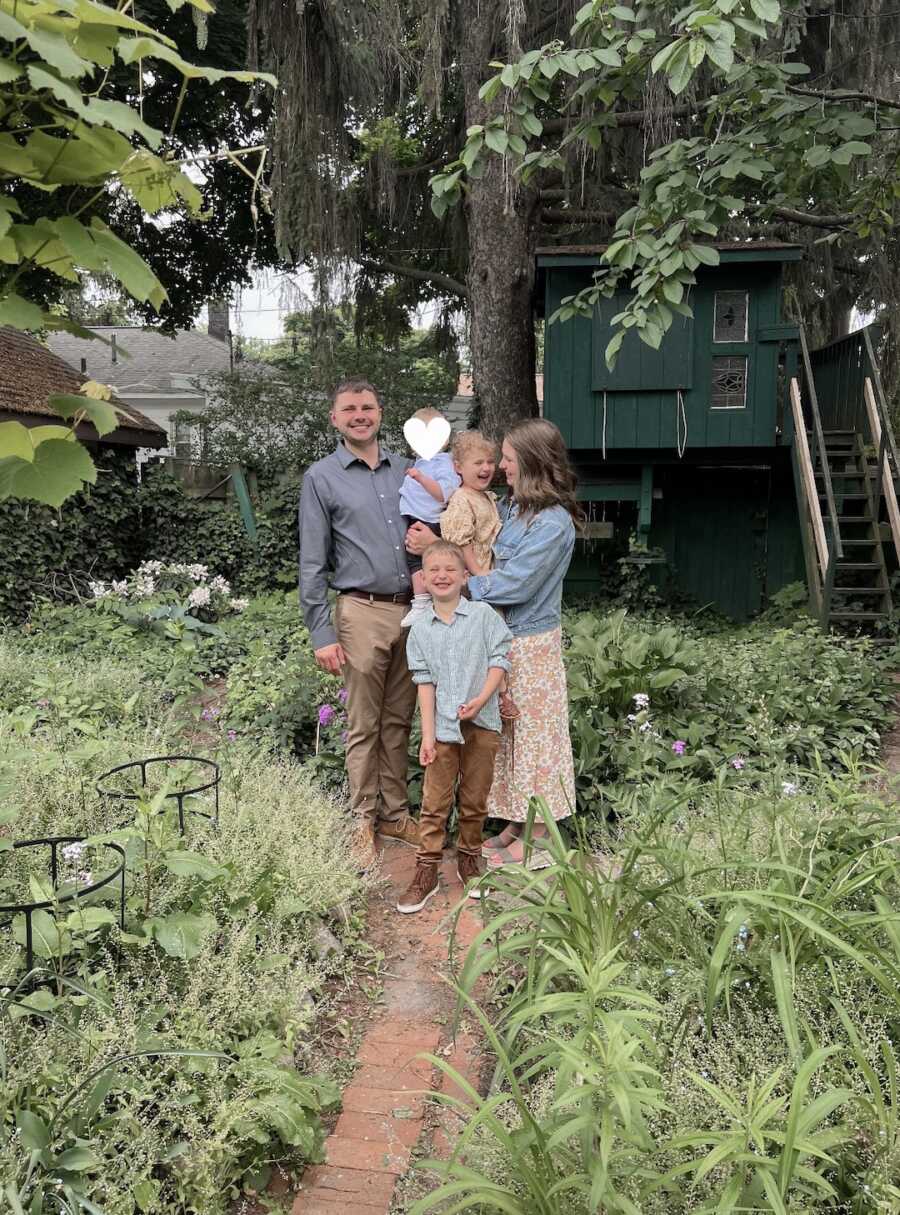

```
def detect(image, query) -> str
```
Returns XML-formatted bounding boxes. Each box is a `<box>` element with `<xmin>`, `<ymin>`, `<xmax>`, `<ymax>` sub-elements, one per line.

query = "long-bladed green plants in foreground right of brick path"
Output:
<box><xmin>413</xmin><ymin>770</ymin><xmax>900</xmax><ymax>1215</ymax></box>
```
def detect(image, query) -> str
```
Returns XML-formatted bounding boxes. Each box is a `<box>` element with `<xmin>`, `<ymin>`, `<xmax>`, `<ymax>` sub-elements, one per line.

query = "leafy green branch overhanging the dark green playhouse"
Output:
<box><xmin>431</xmin><ymin>0</ymin><xmax>900</xmax><ymax>366</ymax></box>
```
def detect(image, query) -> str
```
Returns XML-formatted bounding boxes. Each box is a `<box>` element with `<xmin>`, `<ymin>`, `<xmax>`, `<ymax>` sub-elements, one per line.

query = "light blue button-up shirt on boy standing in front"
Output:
<box><xmin>406</xmin><ymin>599</ymin><xmax>513</xmax><ymax>742</ymax></box>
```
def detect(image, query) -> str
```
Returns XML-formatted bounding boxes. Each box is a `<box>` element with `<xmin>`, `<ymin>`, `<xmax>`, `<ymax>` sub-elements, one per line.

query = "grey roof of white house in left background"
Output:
<box><xmin>47</xmin><ymin>324</ymin><xmax>231</xmax><ymax>394</ymax></box>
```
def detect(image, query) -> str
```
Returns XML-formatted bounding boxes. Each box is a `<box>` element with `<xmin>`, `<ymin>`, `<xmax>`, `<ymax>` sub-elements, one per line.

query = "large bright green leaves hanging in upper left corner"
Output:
<box><xmin>0</xmin><ymin>0</ymin><xmax>274</xmax><ymax>507</ymax></box>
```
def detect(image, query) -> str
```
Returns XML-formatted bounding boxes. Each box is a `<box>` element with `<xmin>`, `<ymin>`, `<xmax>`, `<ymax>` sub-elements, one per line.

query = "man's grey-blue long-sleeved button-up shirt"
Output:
<box><xmin>300</xmin><ymin>442</ymin><xmax>411</xmax><ymax>650</ymax></box>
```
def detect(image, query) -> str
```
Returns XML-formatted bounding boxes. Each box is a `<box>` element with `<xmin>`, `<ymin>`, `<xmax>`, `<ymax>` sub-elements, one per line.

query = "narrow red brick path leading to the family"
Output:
<box><xmin>291</xmin><ymin>844</ymin><xmax>482</xmax><ymax>1215</ymax></box>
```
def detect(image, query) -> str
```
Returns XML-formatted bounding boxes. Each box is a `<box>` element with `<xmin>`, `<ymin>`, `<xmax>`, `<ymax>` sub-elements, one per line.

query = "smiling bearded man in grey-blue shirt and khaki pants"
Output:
<box><xmin>300</xmin><ymin>379</ymin><xmax>419</xmax><ymax>868</ymax></box>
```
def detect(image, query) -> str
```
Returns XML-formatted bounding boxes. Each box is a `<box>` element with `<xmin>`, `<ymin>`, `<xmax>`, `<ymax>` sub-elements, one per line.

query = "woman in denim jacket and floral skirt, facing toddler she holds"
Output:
<box><xmin>410</xmin><ymin>418</ymin><xmax>582</xmax><ymax>868</ymax></box>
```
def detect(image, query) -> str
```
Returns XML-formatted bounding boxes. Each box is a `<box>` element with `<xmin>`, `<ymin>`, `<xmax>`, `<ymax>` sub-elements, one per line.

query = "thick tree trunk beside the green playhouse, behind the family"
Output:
<box><xmin>458</xmin><ymin>0</ymin><xmax>540</xmax><ymax>437</ymax></box>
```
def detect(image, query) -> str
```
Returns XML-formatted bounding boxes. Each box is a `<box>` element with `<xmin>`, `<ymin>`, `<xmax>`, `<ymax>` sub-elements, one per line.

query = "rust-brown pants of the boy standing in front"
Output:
<box><xmin>419</xmin><ymin>722</ymin><xmax>500</xmax><ymax>863</ymax></box>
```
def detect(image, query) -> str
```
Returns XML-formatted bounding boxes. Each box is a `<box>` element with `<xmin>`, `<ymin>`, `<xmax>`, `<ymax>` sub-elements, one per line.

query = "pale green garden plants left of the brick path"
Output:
<box><xmin>0</xmin><ymin>631</ymin><xmax>360</xmax><ymax>1215</ymax></box>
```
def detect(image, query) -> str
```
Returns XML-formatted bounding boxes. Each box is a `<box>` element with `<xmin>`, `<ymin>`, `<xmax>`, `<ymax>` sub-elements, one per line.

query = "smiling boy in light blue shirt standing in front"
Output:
<box><xmin>397</xmin><ymin>539</ymin><xmax>513</xmax><ymax>912</ymax></box>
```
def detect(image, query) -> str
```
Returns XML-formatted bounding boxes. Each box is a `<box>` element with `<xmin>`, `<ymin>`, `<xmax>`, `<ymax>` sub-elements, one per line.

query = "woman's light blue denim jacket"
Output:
<box><xmin>469</xmin><ymin>503</ymin><xmax>574</xmax><ymax>637</ymax></box>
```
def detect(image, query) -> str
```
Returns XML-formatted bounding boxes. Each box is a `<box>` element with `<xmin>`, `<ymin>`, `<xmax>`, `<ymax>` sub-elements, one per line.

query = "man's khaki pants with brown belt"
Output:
<box><xmin>334</xmin><ymin>595</ymin><xmax>415</xmax><ymax>823</ymax></box>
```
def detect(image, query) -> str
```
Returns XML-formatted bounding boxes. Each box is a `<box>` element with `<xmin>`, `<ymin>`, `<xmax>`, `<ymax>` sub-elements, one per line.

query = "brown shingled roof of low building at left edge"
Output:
<box><xmin>0</xmin><ymin>326</ymin><xmax>166</xmax><ymax>447</ymax></box>
